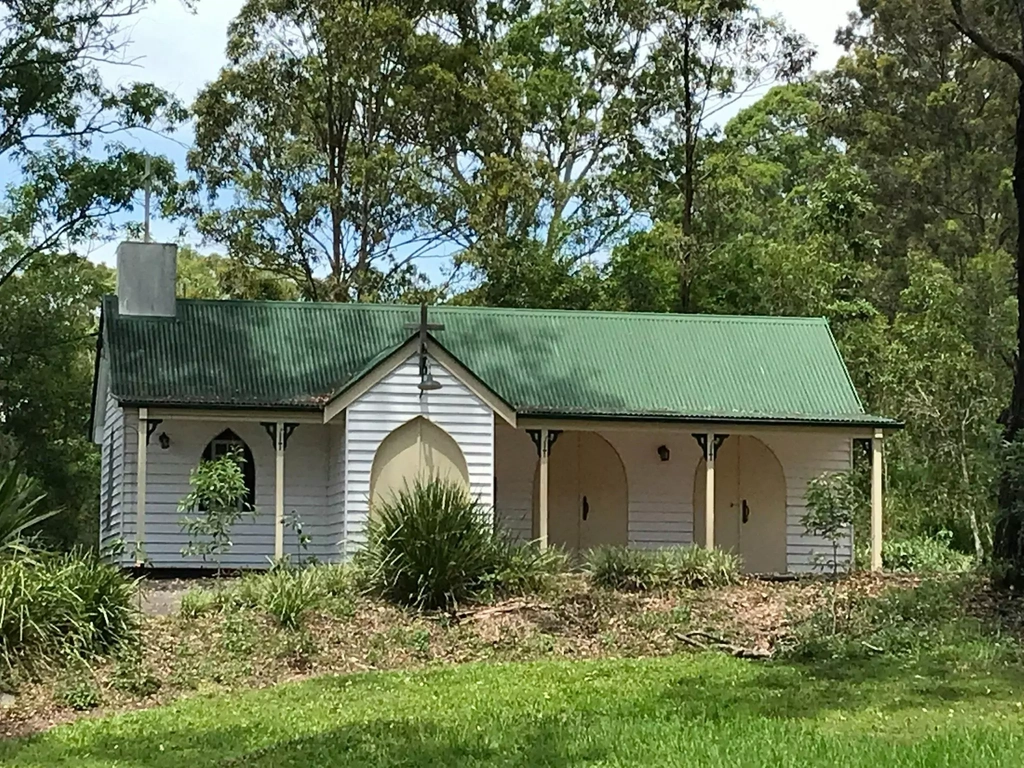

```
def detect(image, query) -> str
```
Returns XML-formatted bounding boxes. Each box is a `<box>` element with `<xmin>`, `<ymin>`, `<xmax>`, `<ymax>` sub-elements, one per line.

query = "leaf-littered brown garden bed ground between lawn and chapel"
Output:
<box><xmin>0</xmin><ymin>574</ymin><xmax>915</xmax><ymax>737</ymax></box>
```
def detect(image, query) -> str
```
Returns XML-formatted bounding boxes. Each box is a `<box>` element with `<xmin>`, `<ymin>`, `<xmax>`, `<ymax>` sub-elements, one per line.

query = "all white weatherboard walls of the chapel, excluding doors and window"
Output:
<box><xmin>100</xmin><ymin>391</ymin><xmax>853</xmax><ymax>572</ymax></box>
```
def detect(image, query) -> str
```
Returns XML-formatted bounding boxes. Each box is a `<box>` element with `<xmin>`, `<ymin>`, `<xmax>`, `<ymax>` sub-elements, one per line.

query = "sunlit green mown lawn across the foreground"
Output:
<box><xmin>6</xmin><ymin>655</ymin><xmax>1024</xmax><ymax>768</ymax></box>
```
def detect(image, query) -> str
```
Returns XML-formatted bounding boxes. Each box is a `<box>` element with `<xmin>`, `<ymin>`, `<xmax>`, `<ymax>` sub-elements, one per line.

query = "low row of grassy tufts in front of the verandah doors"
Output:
<box><xmin>586</xmin><ymin>547</ymin><xmax>739</xmax><ymax>592</ymax></box>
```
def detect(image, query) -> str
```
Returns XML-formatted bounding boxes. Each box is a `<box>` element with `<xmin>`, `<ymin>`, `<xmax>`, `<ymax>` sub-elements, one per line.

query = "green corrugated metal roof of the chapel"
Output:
<box><xmin>97</xmin><ymin>297</ymin><xmax>895</xmax><ymax>424</ymax></box>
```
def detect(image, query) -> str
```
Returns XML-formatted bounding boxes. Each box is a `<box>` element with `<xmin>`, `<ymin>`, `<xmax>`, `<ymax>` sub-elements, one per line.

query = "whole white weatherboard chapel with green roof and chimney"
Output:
<box><xmin>92</xmin><ymin>243</ymin><xmax>900</xmax><ymax>572</ymax></box>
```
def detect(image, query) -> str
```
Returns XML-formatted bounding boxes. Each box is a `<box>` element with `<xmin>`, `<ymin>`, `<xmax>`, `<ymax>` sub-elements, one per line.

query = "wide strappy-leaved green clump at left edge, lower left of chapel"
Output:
<box><xmin>0</xmin><ymin>548</ymin><xmax>138</xmax><ymax>670</ymax></box>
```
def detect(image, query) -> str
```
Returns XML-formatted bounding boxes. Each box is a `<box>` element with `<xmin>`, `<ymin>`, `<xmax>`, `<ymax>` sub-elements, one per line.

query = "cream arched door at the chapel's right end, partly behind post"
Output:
<box><xmin>693</xmin><ymin>435</ymin><xmax>786</xmax><ymax>573</ymax></box>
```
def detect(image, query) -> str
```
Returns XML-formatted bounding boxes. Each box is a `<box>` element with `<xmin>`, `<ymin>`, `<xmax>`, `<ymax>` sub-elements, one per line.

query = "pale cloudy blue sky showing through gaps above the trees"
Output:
<box><xmin>87</xmin><ymin>0</ymin><xmax>856</xmax><ymax>263</ymax></box>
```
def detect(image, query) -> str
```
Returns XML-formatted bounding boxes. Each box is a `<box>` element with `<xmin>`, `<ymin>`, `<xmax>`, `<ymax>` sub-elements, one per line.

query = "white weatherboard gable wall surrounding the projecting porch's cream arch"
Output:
<box><xmin>345</xmin><ymin>355</ymin><xmax>495</xmax><ymax>555</ymax></box>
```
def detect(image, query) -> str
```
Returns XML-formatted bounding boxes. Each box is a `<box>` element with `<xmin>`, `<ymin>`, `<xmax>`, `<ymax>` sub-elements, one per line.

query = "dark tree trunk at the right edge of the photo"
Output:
<box><xmin>992</xmin><ymin>81</ymin><xmax>1024</xmax><ymax>578</ymax></box>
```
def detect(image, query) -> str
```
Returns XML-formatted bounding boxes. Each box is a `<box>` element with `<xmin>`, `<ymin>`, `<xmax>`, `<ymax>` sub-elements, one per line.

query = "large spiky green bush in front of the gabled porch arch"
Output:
<box><xmin>356</xmin><ymin>479</ymin><xmax>565</xmax><ymax>610</ymax></box>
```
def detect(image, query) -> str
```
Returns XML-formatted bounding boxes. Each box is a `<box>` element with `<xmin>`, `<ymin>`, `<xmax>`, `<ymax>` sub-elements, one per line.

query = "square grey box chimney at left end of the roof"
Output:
<box><xmin>118</xmin><ymin>243</ymin><xmax>178</xmax><ymax>317</ymax></box>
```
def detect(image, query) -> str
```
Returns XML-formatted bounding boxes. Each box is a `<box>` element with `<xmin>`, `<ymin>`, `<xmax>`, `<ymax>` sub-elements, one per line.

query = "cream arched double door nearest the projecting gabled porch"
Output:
<box><xmin>534</xmin><ymin>432</ymin><xmax>629</xmax><ymax>551</ymax></box>
